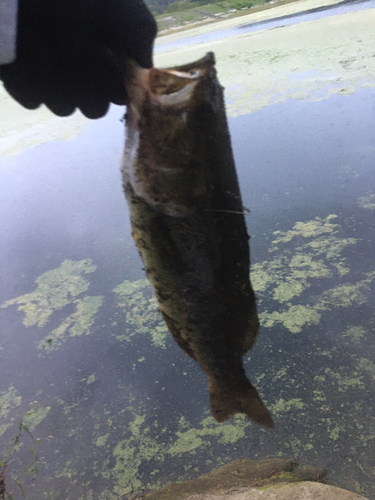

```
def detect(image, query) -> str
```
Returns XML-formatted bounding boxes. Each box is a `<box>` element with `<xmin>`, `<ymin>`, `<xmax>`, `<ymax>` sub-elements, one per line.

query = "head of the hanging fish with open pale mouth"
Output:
<box><xmin>123</xmin><ymin>54</ymin><xmax>216</xmax><ymax>217</ymax></box>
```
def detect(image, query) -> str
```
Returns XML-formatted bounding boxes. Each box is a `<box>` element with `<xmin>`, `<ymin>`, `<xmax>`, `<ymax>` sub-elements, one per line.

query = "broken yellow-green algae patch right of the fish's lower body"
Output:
<box><xmin>251</xmin><ymin>214</ymin><xmax>364</xmax><ymax>333</ymax></box>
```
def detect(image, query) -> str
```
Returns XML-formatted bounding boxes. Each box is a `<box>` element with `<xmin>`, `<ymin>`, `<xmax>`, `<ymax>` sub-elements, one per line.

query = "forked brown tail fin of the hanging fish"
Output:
<box><xmin>209</xmin><ymin>378</ymin><xmax>274</xmax><ymax>428</ymax></box>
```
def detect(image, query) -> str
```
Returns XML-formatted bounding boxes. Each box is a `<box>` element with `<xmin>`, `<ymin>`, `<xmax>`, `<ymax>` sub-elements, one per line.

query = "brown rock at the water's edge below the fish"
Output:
<box><xmin>142</xmin><ymin>459</ymin><xmax>366</xmax><ymax>500</ymax></box>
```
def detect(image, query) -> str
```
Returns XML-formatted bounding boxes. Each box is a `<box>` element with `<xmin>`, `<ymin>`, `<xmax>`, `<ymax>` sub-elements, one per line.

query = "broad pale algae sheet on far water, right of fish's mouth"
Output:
<box><xmin>155</xmin><ymin>9</ymin><xmax>375</xmax><ymax>116</ymax></box>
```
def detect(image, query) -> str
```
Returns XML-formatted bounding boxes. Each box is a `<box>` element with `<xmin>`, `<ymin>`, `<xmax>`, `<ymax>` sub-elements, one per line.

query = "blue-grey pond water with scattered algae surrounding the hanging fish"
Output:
<box><xmin>0</xmin><ymin>83</ymin><xmax>375</xmax><ymax>500</ymax></box>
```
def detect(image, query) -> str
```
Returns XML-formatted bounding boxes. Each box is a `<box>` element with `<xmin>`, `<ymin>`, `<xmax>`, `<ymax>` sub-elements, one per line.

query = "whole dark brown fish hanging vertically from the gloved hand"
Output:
<box><xmin>121</xmin><ymin>52</ymin><xmax>274</xmax><ymax>428</ymax></box>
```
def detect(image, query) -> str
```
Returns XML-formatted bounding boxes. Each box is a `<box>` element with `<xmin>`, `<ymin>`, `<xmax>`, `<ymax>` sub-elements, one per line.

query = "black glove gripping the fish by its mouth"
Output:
<box><xmin>0</xmin><ymin>0</ymin><xmax>157</xmax><ymax>118</ymax></box>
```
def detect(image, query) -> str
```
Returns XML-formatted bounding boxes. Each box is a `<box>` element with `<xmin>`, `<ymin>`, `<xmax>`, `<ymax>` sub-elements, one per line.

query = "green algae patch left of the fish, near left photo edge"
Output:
<box><xmin>0</xmin><ymin>259</ymin><xmax>103</xmax><ymax>353</ymax></box>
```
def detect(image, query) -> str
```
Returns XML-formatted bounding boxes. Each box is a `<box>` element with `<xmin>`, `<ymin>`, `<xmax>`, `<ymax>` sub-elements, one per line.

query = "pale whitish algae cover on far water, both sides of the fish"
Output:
<box><xmin>0</xmin><ymin>0</ymin><xmax>375</xmax><ymax>155</ymax></box>
